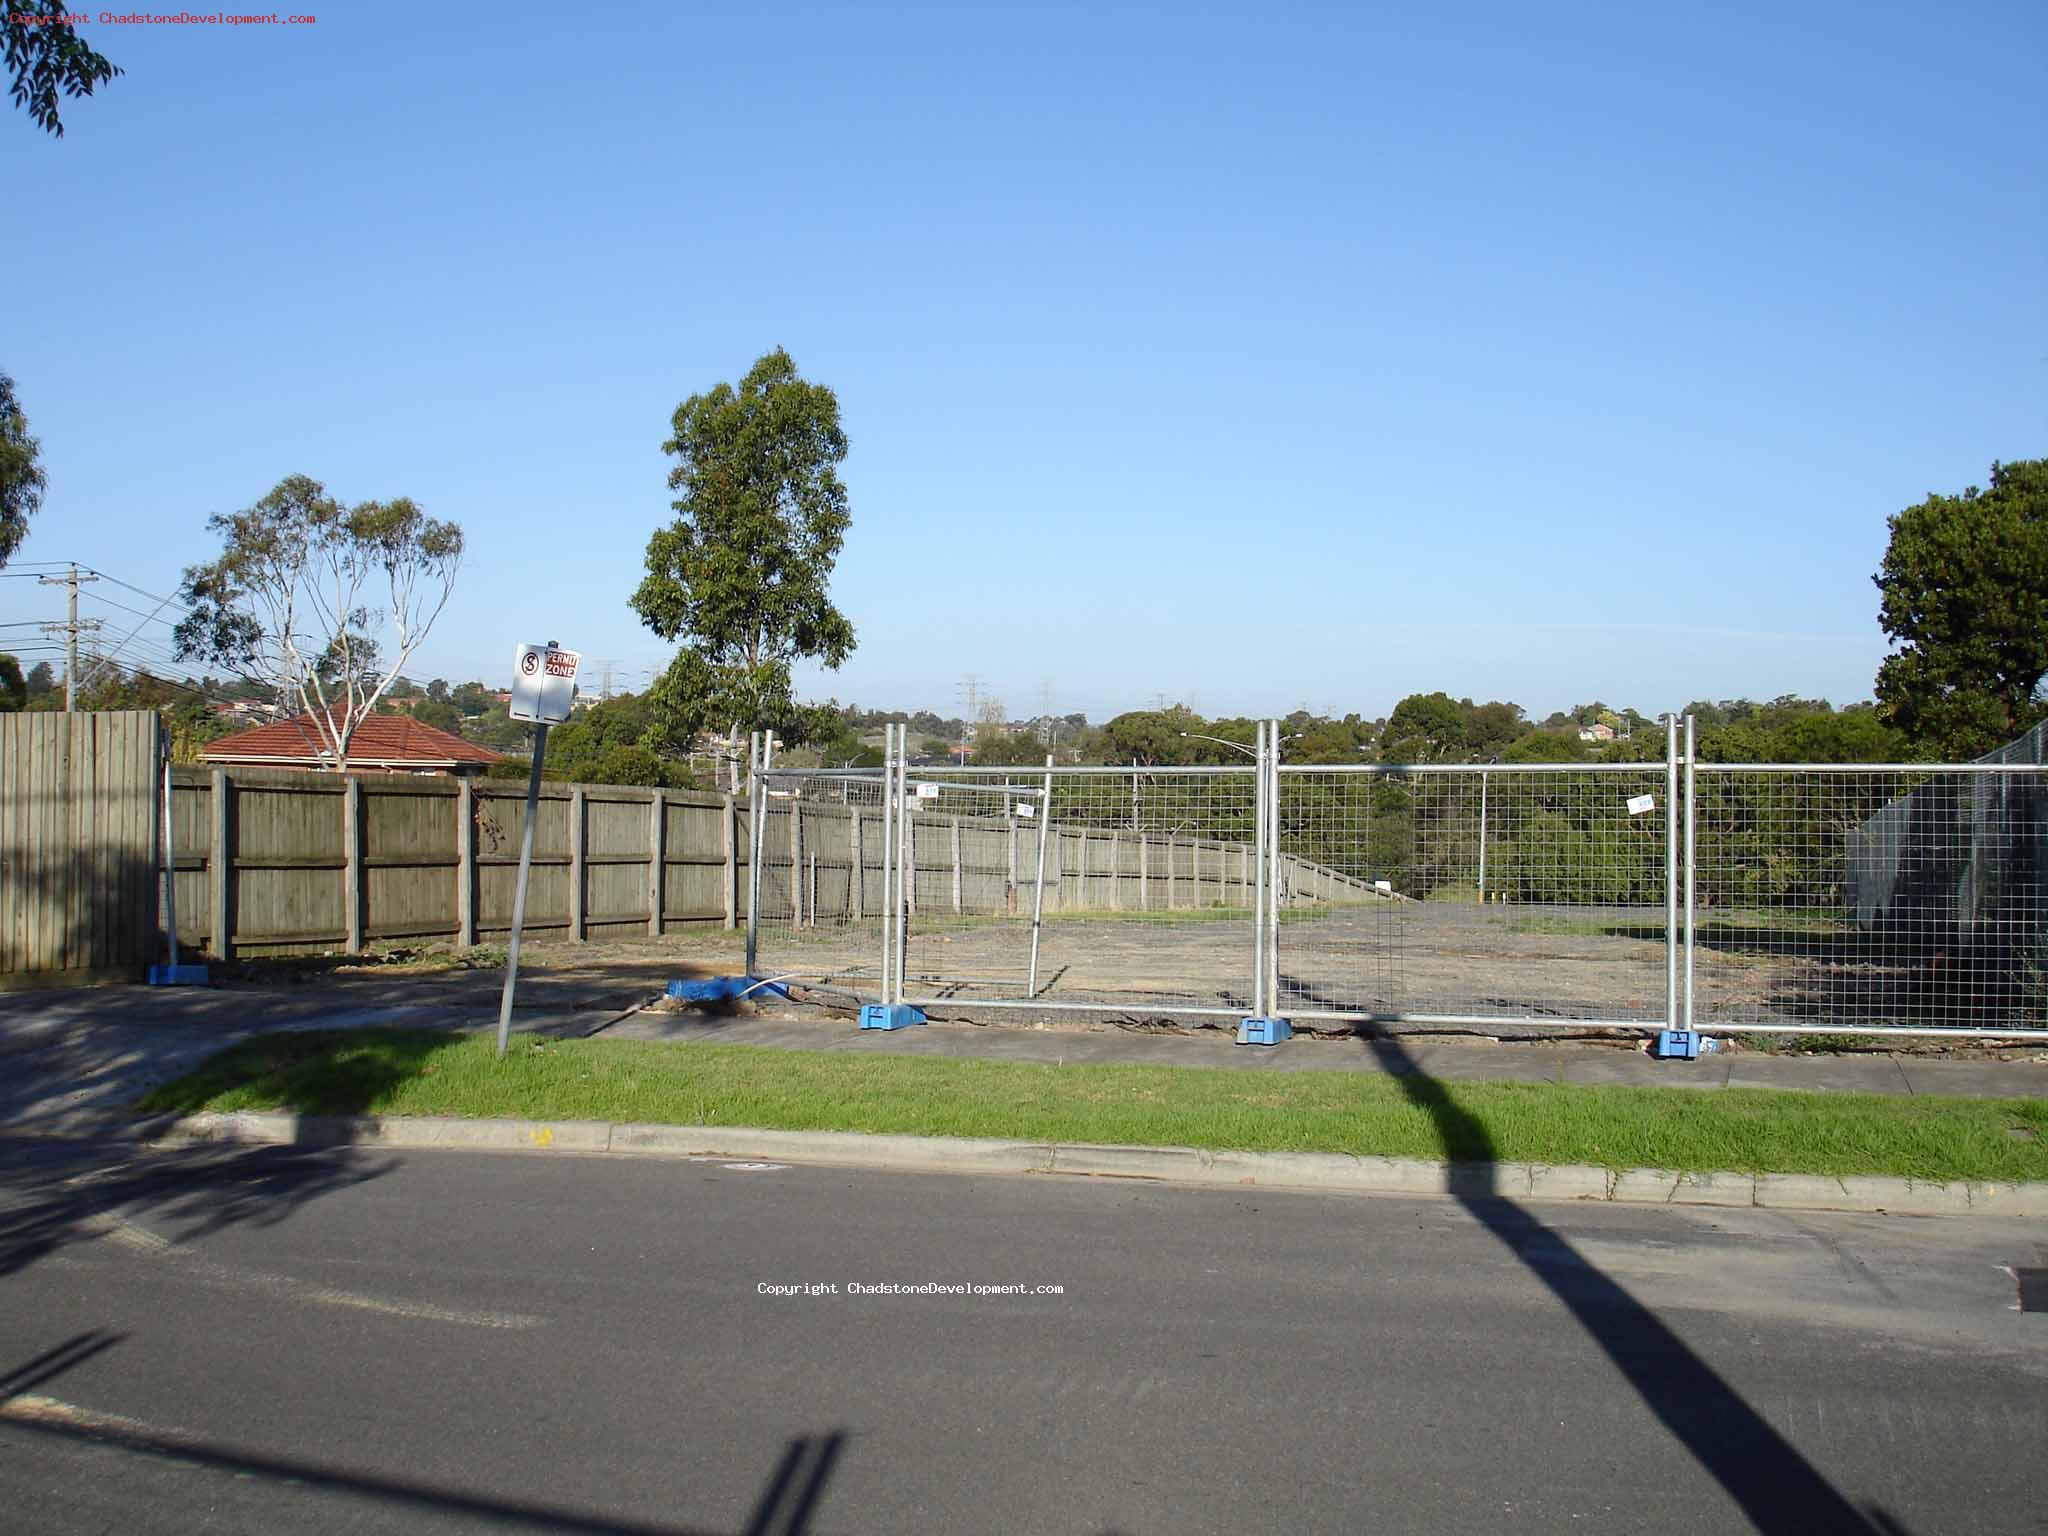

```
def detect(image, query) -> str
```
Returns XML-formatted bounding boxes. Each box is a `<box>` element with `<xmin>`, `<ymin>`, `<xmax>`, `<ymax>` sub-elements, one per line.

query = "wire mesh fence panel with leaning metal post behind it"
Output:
<box><xmin>903</xmin><ymin>766</ymin><xmax>1260</xmax><ymax>1014</ymax></box>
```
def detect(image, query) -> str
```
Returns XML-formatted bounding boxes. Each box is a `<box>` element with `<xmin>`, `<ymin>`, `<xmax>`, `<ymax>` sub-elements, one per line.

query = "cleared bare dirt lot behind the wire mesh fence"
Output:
<box><xmin>760</xmin><ymin>901</ymin><xmax>2042</xmax><ymax>1028</ymax></box>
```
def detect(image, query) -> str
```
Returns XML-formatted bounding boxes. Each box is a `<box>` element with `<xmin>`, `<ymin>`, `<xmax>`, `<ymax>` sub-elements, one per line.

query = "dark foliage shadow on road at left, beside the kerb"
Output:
<box><xmin>0</xmin><ymin>1139</ymin><xmax>395</xmax><ymax>1276</ymax></box>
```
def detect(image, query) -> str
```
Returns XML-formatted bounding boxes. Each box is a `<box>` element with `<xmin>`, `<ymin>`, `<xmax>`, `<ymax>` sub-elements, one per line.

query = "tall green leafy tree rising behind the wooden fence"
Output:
<box><xmin>633</xmin><ymin>348</ymin><xmax>854</xmax><ymax>774</ymax></box>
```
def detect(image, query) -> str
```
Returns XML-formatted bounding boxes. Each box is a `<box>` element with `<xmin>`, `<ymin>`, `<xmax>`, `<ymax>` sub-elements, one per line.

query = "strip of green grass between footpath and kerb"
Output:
<box><xmin>137</xmin><ymin>1030</ymin><xmax>2048</xmax><ymax>1180</ymax></box>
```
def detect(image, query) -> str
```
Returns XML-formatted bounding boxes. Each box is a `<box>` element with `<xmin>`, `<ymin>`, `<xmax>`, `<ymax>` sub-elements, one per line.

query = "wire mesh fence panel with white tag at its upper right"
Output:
<box><xmin>1274</xmin><ymin>764</ymin><xmax>1671</xmax><ymax>1024</ymax></box>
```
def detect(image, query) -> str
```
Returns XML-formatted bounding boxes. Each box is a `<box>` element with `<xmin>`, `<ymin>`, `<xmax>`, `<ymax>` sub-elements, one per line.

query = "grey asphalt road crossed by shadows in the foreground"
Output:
<box><xmin>0</xmin><ymin>1141</ymin><xmax>2048</xmax><ymax>1536</ymax></box>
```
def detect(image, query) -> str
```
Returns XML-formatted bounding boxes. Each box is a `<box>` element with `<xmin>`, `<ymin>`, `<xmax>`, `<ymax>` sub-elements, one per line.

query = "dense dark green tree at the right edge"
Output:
<box><xmin>1872</xmin><ymin>459</ymin><xmax>2048</xmax><ymax>758</ymax></box>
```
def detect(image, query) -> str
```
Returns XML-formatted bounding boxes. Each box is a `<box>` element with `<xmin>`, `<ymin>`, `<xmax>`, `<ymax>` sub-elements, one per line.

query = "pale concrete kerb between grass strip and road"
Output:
<box><xmin>80</xmin><ymin>1112</ymin><xmax>2048</xmax><ymax>1221</ymax></box>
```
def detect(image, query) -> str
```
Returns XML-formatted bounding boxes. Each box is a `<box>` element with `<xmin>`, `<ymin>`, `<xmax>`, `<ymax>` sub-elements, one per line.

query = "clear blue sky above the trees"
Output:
<box><xmin>0</xmin><ymin>0</ymin><xmax>2048</xmax><ymax>719</ymax></box>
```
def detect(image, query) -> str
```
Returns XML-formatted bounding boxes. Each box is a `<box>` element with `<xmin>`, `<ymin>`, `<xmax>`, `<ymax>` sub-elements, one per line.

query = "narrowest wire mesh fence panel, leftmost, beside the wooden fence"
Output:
<box><xmin>750</xmin><ymin>768</ymin><xmax>885</xmax><ymax>997</ymax></box>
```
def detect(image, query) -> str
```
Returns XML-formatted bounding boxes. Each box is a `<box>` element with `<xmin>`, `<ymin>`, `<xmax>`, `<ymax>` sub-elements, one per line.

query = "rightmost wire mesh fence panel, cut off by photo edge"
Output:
<box><xmin>1692</xmin><ymin>762</ymin><xmax>2048</xmax><ymax>1032</ymax></box>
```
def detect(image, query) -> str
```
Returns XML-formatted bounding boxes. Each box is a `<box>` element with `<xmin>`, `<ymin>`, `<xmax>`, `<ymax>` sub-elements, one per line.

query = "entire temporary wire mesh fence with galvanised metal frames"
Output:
<box><xmin>750</xmin><ymin>727</ymin><xmax>2048</xmax><ymax>1034</ymax></box>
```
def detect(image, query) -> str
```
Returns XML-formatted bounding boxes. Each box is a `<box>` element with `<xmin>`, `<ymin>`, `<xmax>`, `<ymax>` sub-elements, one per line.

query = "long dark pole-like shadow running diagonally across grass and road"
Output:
<box><xmin>1372</xmin><ymin>1036</ymin><xmax>1905</xmax><ymax>1536</ymax></box>
